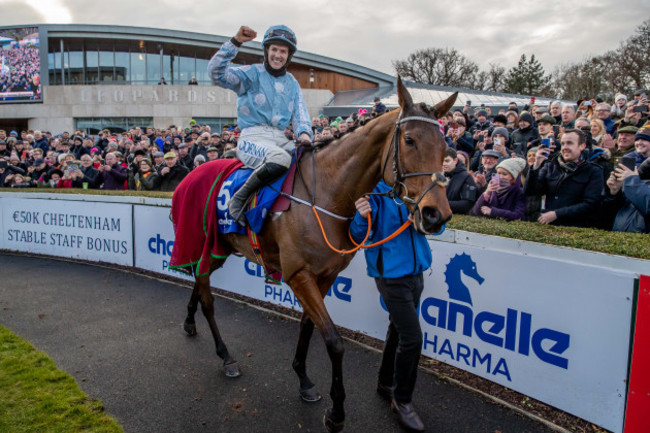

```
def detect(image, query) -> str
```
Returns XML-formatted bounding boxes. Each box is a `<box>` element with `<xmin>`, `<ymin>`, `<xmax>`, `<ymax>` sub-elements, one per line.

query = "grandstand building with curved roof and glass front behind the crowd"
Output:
<box><xmin>0</xmin><ymin>24</ymin><xmax>544</xmax><ymax>133</ymax></box>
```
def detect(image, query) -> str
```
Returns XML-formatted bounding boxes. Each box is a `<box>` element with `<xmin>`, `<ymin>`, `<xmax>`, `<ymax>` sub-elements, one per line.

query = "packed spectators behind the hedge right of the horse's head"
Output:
<box><xmin>440</xmin><ymin>89</ymin><xmax>650</xmax><ymax>233</ymax></box>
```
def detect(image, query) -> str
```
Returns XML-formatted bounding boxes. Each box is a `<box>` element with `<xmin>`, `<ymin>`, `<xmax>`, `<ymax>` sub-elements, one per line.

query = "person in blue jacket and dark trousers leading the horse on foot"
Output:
<box><xmin>350</xmin><ymin>181</ymin><xmax>444</xmax><ymax>431</ymax></box>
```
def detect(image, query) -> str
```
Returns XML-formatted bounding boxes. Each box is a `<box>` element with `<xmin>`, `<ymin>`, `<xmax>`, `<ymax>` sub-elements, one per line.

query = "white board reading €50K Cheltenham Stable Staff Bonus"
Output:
<box><xmin>2</xmin><ymin>197</ymin><xmax>133</xmax><ymax>266</ymax></box>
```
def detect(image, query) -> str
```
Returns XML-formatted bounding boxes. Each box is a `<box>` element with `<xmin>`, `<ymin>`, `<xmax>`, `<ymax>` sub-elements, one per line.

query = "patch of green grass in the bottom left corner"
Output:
<box><xmin>0</xmin><ymin>326</ymin><xmax>123</xmax><ymax>433</ymax></box>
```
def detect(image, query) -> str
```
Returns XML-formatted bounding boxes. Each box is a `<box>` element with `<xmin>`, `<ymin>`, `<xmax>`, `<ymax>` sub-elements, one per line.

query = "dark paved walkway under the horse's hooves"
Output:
<box><xmin>0</xmin><ymin>254</ymin><xmax>550</xmax><ymax>433</ymax></box>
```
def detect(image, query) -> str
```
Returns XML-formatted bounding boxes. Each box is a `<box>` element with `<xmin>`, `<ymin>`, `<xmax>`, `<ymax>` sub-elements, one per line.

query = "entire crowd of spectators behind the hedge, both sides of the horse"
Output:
<box><xmin>0</xmin><ymin>90</ymin><xmax>650</xmax><ymax>233</ymax></box>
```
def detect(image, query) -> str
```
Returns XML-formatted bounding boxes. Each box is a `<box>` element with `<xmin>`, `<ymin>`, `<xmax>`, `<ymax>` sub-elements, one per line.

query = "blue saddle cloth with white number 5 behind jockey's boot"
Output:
<box><xmin>217</xmin><ymin>168</ymin><xmax>289</xmax><ymax>234</ymax></box>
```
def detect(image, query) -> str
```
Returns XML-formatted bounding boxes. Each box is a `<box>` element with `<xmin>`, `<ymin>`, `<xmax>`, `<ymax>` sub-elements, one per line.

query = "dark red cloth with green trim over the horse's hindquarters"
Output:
<box><xmin>169</xmin><ymin>159</ymin><xmax>243</xmax><ymax>276</ymax></box>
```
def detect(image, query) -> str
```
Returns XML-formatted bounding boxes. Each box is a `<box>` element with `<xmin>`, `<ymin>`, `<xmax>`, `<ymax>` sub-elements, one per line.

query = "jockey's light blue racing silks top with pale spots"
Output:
<box><xmin>208</xmin><ymin>41</ymin><xmax>312</xmax><ymax>137</ymax></box>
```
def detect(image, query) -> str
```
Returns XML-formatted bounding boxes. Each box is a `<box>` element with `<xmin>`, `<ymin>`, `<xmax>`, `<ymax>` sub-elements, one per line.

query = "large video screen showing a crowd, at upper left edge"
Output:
<box><xmin>0</xmin><ymin>27</ymin><xmax>41</xmax><ymax>102</ymax></box>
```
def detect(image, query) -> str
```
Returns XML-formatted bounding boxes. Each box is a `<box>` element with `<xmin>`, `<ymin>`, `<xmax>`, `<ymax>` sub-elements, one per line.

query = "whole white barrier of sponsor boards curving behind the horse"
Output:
<box><xmin>0</xmin><ymin>193</ymin><xmax>650</xmax><ymax>433</ymax></box>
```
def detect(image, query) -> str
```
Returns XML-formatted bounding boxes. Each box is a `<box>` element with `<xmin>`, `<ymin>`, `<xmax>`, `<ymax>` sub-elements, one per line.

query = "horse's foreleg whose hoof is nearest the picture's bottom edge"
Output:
<box><xmin>288</xmin><ymin>271</ymin><xmax>345</xmax><ymax>432</ymax></box>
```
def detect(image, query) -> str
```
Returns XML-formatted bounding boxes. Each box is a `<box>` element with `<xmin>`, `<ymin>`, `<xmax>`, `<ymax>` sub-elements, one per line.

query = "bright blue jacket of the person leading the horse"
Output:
<box><xmin>350</xmin><ymin>180</ymin><xmax>431</xmax><ymax>278</ymax></box>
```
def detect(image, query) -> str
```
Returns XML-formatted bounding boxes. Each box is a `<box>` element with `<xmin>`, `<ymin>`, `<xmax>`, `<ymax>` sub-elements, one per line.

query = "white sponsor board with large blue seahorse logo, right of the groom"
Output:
<box><xmin>420</xmin><ymin>242</ymin><xmax>634</xmax><ymax>432</ymax></box>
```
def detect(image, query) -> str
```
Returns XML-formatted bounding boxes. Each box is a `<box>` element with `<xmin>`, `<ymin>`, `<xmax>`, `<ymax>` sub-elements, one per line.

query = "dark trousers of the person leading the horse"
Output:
<box><xmin>375</xmin><ymin>273</ymin><xmax>424</xmax><ymax>403</ymax></box>
